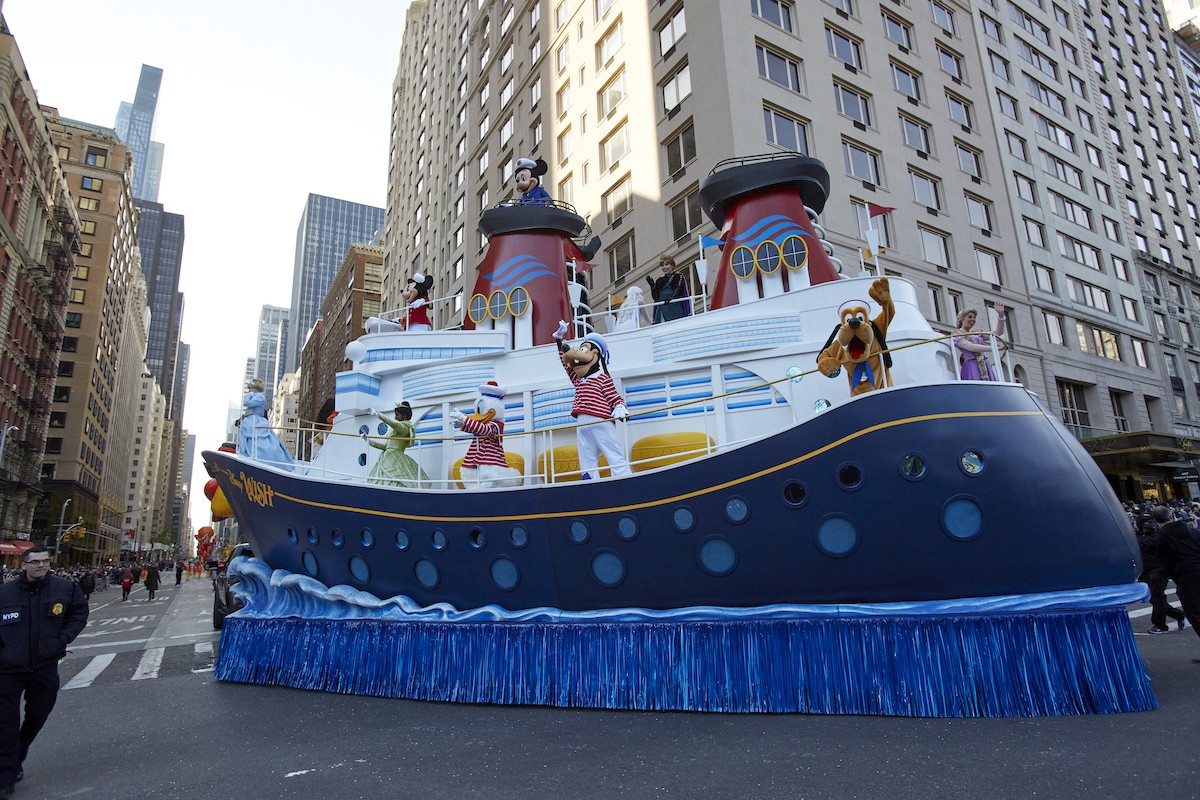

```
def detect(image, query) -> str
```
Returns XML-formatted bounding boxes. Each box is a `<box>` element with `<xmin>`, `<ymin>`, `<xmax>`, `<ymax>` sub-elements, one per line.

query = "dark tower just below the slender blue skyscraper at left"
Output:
<box><xmin>137</xmin><ymin>200</ymin><xmax>184</xmax><ymax>419</ymax></box>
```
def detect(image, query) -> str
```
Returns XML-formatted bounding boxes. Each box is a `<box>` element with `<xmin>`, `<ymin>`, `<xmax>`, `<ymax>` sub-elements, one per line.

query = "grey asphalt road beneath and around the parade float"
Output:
<box><xmin>14</xmin><ymin>582</ymin><xmax>1200</xmax><ymax>800</ymax></box>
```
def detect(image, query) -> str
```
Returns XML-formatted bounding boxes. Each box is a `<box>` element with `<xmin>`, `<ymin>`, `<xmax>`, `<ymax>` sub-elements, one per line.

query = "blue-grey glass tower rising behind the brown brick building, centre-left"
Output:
<box><xmin>281</xmin><ymin>194</ymin><xmax>384</xmax><ymax>372</ymax></box>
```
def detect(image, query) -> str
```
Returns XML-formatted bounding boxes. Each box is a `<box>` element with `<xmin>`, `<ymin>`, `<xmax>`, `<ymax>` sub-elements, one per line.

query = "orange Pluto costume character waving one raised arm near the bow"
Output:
<box><xmin>817</xmin><ymin>278</ymin><xmax>896</xmax><ymax>397</ymax></box>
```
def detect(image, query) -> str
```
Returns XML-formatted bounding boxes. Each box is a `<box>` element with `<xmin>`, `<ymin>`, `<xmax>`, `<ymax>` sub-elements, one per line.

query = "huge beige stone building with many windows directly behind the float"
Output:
<box><xmin>383</xmin><ymin>0</ymin><xmax>1200</xmax><ymax>497</ymax></box>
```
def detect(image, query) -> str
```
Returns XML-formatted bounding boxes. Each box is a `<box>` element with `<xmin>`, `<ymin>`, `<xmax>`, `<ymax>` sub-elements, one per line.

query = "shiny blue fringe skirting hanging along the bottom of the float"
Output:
<box><xmin>216</xmin><ymin>606</ymin><xmax>1158</xmax><ymax>717</ymax></box>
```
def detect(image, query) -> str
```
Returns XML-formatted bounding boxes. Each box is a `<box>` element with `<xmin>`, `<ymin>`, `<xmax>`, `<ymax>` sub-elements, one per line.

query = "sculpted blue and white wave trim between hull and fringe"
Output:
<box><xmin>229</xmin><ymin>558</ymin><xmax>1148</xmax><ymax>622</ymax></box>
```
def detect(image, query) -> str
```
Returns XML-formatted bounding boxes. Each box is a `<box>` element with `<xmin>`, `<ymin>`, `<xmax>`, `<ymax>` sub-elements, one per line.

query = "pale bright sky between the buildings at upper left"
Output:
<box><xmin>0</xmin><ymin>0</ymin><xmax>408</xmax><ymax>537</ymax></box>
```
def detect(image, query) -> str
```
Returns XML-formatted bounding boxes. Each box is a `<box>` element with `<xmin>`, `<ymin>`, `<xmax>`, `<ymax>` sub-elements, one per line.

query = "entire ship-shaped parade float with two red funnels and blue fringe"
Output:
<box><xmin>204</xmin><ymin>155</ymin><xmax>1157</xmax><ymax>716</ymax></box>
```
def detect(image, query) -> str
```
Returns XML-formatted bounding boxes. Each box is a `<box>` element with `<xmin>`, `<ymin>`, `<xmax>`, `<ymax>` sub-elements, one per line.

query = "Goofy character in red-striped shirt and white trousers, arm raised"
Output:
<box><xmin>554</xmin><ymin>320</ymin><xmax>632</xmax><ymax>480</ymax></box>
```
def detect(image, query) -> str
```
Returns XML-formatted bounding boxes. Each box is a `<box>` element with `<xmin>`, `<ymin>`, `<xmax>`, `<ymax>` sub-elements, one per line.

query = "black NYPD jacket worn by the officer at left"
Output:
<box><xmin>0</xmin><ymin>575</ymin><xmax>88</xmax><ymax>673</ymax></box>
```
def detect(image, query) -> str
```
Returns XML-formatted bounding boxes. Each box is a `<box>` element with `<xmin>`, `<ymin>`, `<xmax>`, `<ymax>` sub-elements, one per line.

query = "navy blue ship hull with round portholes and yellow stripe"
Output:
<box><xmin>204</xmin><ymin>383</ymin><xmax>1140</xmax><ymax>610</ymax></box>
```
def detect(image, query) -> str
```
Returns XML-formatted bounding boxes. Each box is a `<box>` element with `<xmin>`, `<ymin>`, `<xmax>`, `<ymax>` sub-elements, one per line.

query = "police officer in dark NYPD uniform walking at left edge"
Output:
<box><xmin>0</xmin><ymin>547</ymin><xmax>88</xmax><ymax>800</ymax></box>
